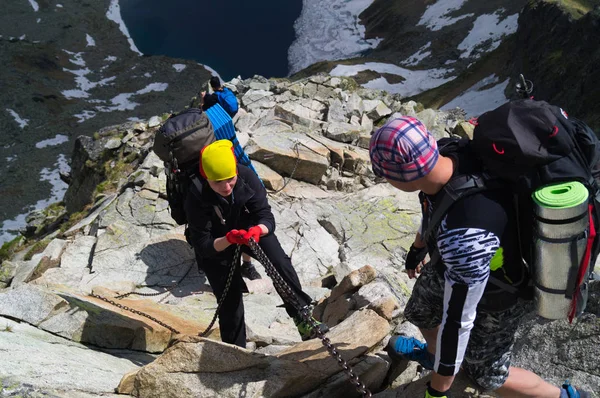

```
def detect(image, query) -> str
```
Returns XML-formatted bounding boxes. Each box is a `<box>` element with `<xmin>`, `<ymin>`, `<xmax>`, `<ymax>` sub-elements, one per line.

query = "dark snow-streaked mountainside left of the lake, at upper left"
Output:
<box><xmin>0</xmin><ymin>0</ymin><xmax>210</xmax><ymax>229</ymax></box>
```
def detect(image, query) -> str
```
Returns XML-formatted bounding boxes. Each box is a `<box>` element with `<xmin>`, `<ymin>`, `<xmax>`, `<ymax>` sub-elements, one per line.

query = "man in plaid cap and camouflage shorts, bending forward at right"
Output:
<box><xmin>369</xmin><ymin>116</ymin><xmax>589</xmax><ymax>398</ymax></box>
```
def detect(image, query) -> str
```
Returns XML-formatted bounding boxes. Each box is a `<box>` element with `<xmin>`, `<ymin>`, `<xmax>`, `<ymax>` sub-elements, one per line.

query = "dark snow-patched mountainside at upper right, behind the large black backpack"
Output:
<box><xmin>298</xmin><ymin>0</ymin><xmax>600</xmax><ymax>130</ymax></box>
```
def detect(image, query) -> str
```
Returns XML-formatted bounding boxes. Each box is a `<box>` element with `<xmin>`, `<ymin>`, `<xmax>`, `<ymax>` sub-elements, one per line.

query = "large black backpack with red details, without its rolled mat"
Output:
<box><xmin>424</xmin><ymin>99</ymin><xmax>600</xmax><ymax>321</ymax></box>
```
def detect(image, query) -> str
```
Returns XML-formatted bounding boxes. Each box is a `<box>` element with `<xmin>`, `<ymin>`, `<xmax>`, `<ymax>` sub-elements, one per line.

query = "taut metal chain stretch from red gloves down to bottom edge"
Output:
<box><xmin>248</xmin><ymin>239</ymin><xmax>372</xmax><ymax>398</ymax></box>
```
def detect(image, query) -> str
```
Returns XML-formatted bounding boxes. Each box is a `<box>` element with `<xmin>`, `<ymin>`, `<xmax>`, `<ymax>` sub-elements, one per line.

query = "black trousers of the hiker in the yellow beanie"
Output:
<box><xmin>196</xmin><ymin>234</ymin><xmax>312</xmax><ymax>347</ymax></box>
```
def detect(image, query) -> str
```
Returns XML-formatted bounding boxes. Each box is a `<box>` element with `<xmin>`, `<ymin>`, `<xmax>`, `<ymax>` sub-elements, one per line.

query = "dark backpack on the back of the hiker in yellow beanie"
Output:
<box><xmin>153</xmin><ymin>108</ymin><xmax>216</xmax><ymax>225</ymax></box>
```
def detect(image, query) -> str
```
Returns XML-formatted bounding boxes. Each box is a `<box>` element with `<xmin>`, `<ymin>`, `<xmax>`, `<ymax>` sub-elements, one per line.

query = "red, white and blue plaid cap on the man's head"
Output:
<box><xmin>369</xmin><ymin>116</ymin><xmax>439</xmax><ymax>182</ymax></box>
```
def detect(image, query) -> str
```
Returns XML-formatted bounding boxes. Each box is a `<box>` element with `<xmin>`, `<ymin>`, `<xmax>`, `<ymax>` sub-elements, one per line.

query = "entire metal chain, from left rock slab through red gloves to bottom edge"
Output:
<box><xmin>90</xmin><ymin>239</ymin><xmax>372</xmax><ymax>398</ymax></box>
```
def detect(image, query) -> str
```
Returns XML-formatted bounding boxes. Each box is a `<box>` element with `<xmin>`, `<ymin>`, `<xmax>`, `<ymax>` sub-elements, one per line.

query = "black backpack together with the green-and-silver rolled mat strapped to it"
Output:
<box><xmin>424</xmin><ymin>99</ymin><xmax>600</xmax><ymax>321</ymax></box>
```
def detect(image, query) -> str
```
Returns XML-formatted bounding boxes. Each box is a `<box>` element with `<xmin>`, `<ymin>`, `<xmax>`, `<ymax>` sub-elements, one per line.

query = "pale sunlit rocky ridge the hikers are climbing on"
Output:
<box><xmin>0</xmin><ymin>75</ymin><xmax>600</xmax><ymax>398</ymax></box>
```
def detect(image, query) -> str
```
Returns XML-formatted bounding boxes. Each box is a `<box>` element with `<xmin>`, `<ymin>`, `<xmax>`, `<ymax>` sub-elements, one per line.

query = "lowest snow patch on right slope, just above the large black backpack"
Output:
<box><xmin>440</xmin><ymin>75</ymin><xmax>508</xmax><ymax>118</ymax></box>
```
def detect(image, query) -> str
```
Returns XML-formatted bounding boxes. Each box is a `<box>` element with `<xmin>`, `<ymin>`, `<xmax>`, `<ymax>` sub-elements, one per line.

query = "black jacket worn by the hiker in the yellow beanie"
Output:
<box><xmin>185</xmin><ymin>164</ymin><xmax>275</xmax><ymax>258</ymax></box>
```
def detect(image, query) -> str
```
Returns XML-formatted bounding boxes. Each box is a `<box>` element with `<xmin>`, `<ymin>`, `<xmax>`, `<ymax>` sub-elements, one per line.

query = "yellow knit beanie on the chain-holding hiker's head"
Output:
<box><xmin>200</xmin><ymin>140</ymin><xmax>237</xmax><ymax>181</ymax></box>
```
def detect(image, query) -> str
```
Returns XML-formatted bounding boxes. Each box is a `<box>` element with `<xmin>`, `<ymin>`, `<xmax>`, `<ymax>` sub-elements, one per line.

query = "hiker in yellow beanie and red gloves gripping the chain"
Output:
<box><xmin>185</xmin><ymin>140</ymin><xmax>328</xmax><ymax>347</ymax></box>
